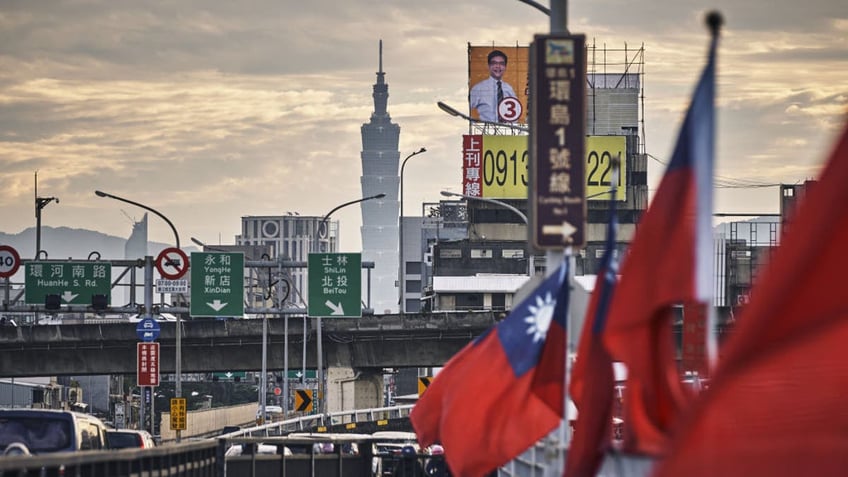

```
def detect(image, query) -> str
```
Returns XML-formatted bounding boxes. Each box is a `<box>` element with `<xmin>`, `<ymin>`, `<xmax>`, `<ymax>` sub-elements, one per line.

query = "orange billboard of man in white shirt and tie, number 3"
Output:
<box><xmin>468</xmin><ymin>44</ymin><xmax>530</xmax><ymax>124</ymax></box>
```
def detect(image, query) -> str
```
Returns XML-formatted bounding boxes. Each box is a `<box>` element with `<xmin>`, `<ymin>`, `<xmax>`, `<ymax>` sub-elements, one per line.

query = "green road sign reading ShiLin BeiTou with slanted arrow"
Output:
<box><xmin>307</xmin><ymin>253</ymin><xmax>362</xmax><ymax>318</ymax></box>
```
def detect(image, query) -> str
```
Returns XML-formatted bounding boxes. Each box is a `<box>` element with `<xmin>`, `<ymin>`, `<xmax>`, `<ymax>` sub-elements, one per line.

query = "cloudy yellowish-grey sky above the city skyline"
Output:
<box><xmin>0</xmin><ymin>0</ymin><xmax>848</xmax><ymax>255</ymax></box>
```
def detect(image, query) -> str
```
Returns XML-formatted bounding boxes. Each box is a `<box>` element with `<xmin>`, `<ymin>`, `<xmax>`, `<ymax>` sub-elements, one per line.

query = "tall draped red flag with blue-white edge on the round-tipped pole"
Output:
<box><xmin>603</xmin><ymin>17</ymin><xmax>718</xmax><ymax>455</ymax></box>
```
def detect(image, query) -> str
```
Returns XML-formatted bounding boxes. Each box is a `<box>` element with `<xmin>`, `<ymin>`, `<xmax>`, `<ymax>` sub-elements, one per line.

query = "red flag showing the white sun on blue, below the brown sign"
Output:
<box><xmin>409</xmin><ymin>263</ymin><xmax>568</xmax><ymax>477</ymax></box>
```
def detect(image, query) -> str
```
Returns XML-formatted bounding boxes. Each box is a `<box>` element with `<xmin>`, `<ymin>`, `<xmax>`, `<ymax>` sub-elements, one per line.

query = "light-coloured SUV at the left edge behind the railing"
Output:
<box><xmin>0</xmin><ymin>409</ymin><xmax>108</xmax><ymax>455</ymax></box>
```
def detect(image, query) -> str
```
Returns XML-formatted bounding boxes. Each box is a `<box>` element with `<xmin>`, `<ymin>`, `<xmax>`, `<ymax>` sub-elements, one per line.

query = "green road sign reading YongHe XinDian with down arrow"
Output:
<box><xmin>189</xmin><ymin>252</ymin><xmax>244</xmax><ymax>316</ymax></box>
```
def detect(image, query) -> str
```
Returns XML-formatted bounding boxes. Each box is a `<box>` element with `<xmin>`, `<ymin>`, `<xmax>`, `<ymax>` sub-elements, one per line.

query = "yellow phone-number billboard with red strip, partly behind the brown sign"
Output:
<box><xmin>462</xmin><ymin>134</ymin><xmax>627</xmax><ymax>201</ymax></box>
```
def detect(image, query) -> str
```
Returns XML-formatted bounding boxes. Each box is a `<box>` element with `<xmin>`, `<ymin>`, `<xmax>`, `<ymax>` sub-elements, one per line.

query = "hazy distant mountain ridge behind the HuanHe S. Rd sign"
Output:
<box><xmin>0</xmin><ymin>226</ymin><xmax>192</xmax><ymax>260</ymax></box>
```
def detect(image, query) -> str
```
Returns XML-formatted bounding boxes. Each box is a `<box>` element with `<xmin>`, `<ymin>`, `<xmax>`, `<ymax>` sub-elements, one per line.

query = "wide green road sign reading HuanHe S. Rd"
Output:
<box><xmin>24</xmin><ymin>262</ymin><xmax>112</xmax><ymax>305</ymax></box>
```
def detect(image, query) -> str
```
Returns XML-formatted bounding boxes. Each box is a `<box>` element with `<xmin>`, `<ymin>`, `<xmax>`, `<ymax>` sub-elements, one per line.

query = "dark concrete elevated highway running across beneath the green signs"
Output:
<box><xmin>0</xmin><ymin>311</ymin><xmax>501</xmax><ymax>377</ymax></box>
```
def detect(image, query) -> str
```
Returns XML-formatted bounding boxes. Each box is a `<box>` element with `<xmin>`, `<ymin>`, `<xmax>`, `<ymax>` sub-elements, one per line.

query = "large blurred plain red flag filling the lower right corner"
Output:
<box><xmin>658</xmin><ymin>123</ymin><xmax>848</xmax><ymax>477</ymax></box>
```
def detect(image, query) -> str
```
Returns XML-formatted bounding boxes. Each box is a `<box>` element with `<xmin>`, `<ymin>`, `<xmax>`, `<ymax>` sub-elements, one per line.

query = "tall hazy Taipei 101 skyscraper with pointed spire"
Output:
<box><xmin>360</xmin><ymin>40</ymin><xmax>400</xmax><ymax>314</ymax></box>
